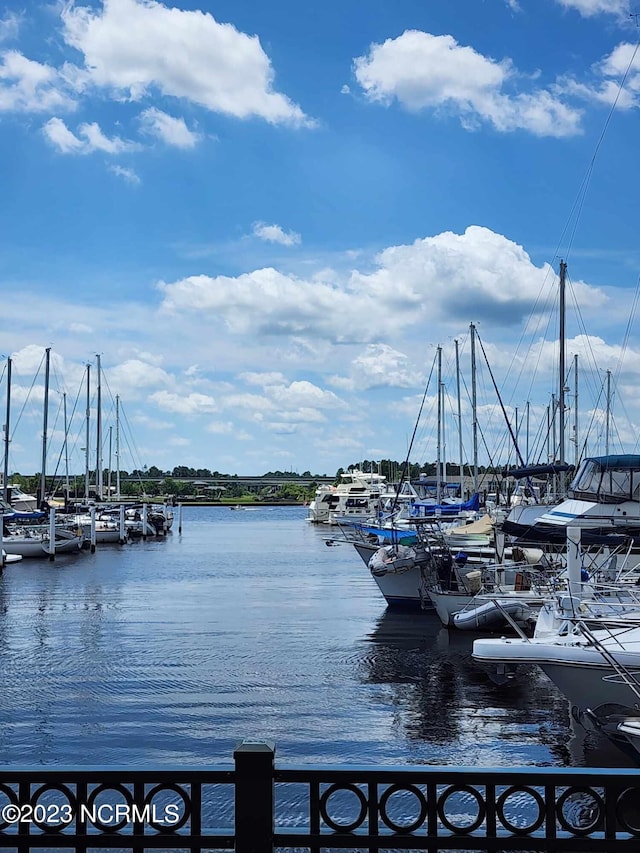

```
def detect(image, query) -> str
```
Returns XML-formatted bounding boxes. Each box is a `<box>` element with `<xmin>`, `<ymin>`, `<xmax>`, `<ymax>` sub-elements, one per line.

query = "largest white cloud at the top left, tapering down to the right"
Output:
<box><xmin>62</xmin><ymin>0</ymin><xmax>308</xmax><ymax>125</ymax></box>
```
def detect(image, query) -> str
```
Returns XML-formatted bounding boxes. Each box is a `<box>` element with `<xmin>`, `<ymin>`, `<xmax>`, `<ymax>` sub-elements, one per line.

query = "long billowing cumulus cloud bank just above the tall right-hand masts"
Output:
<box><xmin>159</xmin><ymin>226</ymin><xmax>607</xmax><ymax>346</ymax></box>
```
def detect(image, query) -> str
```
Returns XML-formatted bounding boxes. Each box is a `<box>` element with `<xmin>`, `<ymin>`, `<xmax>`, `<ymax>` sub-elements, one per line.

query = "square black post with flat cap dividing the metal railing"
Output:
<box><xmin>233</xmin><ymin>740</ymin><xmax>276</xmax><ymax>853</ymax></box>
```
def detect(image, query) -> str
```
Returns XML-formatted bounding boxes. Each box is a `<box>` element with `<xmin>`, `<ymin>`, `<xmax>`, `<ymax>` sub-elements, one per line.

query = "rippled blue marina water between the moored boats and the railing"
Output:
<box><xmin>0</xmin><ymin>507</ymin><xmax>629</xmax><ymax>767</ymax></box>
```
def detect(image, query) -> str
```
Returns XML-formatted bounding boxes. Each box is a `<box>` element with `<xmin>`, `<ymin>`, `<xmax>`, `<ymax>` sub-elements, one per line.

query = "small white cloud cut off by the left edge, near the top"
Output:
<box><xmin>0</xmin><ymin>50</ymin><xmax>75</xmax><ymax>113</ymax></box>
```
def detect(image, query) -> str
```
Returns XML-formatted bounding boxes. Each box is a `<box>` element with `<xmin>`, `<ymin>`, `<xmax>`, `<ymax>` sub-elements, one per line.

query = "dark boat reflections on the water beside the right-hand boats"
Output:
<box><xmin>362</xmin><ymin>610</ymin><xmax>632</xmax><ymax>766</ymax></box>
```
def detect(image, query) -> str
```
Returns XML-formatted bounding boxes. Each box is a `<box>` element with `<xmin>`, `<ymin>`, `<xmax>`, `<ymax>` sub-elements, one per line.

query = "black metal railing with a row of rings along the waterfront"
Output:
<box><xmin>0</xmin><ymin>741</ymin><xmax>640</xmax><ymax>853</ymax></box>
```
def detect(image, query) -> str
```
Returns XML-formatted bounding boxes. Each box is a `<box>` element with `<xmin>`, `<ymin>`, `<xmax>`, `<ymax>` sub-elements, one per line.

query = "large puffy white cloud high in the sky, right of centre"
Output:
<box><xmin>354</xmin><ymin>30</ymin><xmax>581</xmax><ymax>136</ymax></box>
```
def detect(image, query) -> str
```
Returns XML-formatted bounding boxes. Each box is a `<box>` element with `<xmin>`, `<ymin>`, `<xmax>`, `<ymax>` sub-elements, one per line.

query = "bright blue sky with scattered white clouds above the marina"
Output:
<box><xmin>0</xmin><ymin>0</ymin><xmax>640</xmax><ymax>475</ymax></box>
